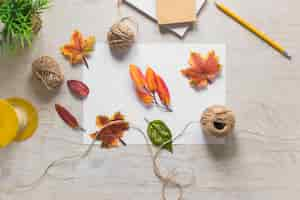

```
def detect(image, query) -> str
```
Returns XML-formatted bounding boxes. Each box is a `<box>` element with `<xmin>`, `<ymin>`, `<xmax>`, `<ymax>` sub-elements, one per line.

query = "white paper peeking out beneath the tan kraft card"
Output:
<box><xmin>124</xmin><ymin>0</ymin><xmax>206</xmax><ymax>38</ymax></box>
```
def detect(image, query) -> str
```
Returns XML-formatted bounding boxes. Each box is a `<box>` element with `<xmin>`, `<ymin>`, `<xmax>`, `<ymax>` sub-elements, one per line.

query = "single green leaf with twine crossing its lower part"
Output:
<box><xmin>147</xmin><ymin>120</ymin><xmax>173</xmax><ymax>153</ymax></box>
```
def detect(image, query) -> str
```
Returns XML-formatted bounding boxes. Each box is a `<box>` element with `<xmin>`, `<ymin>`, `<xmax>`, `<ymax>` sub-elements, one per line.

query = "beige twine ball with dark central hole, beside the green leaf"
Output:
<box><xmin>200</xmin><ymin>105</ymin><xmax>235</xmax><ymax>137</ymax></box>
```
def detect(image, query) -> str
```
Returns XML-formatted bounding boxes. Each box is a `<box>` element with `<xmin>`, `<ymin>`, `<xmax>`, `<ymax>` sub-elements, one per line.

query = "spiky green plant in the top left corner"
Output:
<box><xmin>0</xmin><ymin>0</ymin><xmax>50</xmax><ymax>50</ymax></box>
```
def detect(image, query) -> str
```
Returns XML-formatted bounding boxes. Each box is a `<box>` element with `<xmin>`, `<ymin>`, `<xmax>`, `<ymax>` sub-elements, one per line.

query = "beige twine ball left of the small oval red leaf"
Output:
<box><xmin>32</xmin><ymin>56</ymin><xmax>64</xmax><ymax>90</ymax></box>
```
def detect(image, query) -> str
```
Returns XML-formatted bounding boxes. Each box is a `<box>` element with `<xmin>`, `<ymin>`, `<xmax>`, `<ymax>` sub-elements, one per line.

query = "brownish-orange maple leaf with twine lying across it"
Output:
<box><xmin>90</xmin><ymin>112</ymin><xmax>129</xmax><ymax>148</ymax></box>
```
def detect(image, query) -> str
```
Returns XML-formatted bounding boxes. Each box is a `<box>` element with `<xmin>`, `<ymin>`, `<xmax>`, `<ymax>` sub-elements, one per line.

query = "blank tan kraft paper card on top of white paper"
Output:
<box><xmin>156</xmin><ymin>0</ymin><xmax>196</xmax><ymax>25</ymax></box>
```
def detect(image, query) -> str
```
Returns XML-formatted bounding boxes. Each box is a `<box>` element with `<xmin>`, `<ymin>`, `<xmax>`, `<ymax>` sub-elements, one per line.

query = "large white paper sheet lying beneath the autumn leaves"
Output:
<box><xmin>83</xmin><ymin>43</ymin><xmax>226</xmax><ymax>144</ymax></box>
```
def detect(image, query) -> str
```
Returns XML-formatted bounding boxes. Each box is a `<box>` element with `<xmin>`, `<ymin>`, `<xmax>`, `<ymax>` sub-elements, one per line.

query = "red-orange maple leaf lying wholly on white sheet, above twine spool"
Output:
<box><xmin>181</xmin><ymin>51</ymin><xmax>221</xmax><ymax>89</ymax></box>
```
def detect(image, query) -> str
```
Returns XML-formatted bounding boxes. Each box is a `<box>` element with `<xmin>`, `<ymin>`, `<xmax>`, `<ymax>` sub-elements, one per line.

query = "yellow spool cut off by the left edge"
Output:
<box><xmin>0</xmin><ymin>98</ymin><xmax>38</xmax><ymax>148</ymax></box>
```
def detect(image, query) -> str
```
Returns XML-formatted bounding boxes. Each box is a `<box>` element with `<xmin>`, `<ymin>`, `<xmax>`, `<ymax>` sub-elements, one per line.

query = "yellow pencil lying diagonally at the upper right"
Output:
<box><xmin>215</xmin><ymin>2</ymin><xmax>292</xmax><ymax>59</ymax></box>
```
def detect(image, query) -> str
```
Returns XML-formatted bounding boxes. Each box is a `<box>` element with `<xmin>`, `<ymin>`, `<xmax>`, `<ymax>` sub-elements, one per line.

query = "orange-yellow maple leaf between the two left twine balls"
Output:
<box><xmin>60</xmin><ymin>30</ymin><xmax>96</xmax><ymax>68</ymax></box>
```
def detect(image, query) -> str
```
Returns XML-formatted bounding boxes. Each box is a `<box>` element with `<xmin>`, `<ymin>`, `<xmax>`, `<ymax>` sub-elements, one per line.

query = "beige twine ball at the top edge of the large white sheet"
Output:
<box><xmin>107</xmin><ymin>17</ymin><xmax>136</xmax><ymax>51</ymax></box>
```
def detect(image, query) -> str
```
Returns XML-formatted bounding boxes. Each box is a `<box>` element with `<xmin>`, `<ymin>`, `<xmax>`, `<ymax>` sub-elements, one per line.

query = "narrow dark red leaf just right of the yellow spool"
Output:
<box><xmin>55</xmin><ymin>104</ymin><xmax>84</xmax><ymax>131</ymax></box>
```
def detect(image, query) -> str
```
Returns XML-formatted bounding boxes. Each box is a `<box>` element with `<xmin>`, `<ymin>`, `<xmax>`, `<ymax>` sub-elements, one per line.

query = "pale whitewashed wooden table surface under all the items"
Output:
<box><xmin>0</xmin><ymin>0</ymin><xmax>300</xmax><ymax>200</ymax></box>
